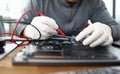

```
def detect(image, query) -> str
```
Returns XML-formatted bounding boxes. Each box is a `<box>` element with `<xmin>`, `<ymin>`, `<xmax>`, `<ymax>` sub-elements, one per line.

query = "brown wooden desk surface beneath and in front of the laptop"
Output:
<box><xmin>0</xmin><ymin>46</ymin><xmax>119</xmax><ymax>74</ymax></box>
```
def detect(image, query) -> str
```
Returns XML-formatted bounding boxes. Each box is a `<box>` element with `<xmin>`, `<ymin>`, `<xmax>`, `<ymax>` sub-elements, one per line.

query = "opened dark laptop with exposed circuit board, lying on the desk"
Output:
<box><xmin>12</xmin><ymin>36</ymin><xmax>120</xmax><ymax>65</ymax></box>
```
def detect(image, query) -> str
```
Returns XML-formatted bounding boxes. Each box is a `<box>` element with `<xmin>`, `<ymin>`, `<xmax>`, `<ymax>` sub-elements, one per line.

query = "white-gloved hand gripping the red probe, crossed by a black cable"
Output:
<box><xmin>24</xmin><ymin>16</ymin><xmax>58</xmax><ymax>39</ymax></box>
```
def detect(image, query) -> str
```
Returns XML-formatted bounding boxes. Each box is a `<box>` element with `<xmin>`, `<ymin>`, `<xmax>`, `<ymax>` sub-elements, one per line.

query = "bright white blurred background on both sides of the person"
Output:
<box><xmin>0</xmin><ymin>0</ymin><xmax>120</xmax><ymax>32</ymax></box>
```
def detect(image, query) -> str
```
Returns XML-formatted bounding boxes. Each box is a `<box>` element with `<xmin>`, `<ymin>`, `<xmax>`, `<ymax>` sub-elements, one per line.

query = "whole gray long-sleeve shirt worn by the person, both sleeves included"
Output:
<box><xmin>17</xmin><ymin>0</ymin><xmax>120</xmax><ymax>40</ymax></box>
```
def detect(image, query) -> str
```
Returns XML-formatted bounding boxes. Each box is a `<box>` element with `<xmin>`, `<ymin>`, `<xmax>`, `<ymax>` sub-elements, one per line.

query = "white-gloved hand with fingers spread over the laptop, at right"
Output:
<box><xmin>76</xmin><ymin>22</ymin><xmax>113</xmax><ymax>47</ymax></box>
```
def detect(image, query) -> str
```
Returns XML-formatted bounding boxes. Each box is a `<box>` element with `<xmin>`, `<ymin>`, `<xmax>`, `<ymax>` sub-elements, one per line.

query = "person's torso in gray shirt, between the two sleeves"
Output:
<box><xmin>37</xmin><ymin>0</ymin><xmax>90</xmax><ymax>35</ymax></box>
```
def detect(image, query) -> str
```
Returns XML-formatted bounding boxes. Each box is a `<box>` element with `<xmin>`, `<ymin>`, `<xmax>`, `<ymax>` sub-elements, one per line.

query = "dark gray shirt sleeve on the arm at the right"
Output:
<box><xmin>90</xmin><ymin>0</ymin><xmax>120</xmax><ymax>41</ymax></box>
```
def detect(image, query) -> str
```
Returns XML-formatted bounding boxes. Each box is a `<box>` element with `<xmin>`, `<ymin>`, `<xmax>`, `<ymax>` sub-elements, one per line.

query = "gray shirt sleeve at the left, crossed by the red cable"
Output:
<box><xmin>16</xmin><ymin>0</ymin><xmax>42</xmax><ymax>35</ymax></box>
